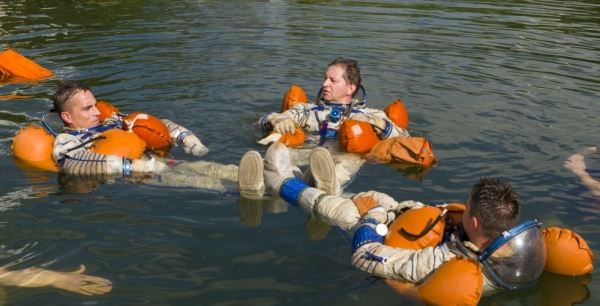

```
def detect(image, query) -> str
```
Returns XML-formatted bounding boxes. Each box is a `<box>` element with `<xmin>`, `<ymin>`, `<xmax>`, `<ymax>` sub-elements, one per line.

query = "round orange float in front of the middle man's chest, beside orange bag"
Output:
<box><xmin>338</xmin><ymin>119</ymin><xmax>379</xmax><ymax>154</ymax></box>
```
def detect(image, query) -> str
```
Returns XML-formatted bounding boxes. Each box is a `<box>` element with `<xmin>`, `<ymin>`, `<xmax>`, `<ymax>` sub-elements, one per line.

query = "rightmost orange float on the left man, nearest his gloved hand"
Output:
<box><xmin>123</xmin><ymin>112</ymin><xmax>173</xmax><ymax>150</ymax></box>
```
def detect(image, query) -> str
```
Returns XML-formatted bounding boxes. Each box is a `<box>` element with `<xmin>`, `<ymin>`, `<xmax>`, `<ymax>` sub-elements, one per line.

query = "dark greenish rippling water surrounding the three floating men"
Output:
<box><xmin>0</xmin><ymin>0</ymin><xmax>600</xmax><ymax>305</ymax></box>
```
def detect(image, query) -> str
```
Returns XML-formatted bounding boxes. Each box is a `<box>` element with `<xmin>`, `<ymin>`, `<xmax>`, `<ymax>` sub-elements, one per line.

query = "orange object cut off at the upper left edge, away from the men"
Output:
<box><xmin>0</xmin><ymin>49</ymin><xmax>52</xmax><ymax>81</ymax></box>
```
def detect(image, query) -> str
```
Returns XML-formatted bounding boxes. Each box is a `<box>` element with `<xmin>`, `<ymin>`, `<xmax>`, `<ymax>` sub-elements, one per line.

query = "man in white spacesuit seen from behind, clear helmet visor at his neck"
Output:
<box><xmin>264</xmin><ymin>143</ymin><xmax>546</xmax><ymax>290</ymax></box>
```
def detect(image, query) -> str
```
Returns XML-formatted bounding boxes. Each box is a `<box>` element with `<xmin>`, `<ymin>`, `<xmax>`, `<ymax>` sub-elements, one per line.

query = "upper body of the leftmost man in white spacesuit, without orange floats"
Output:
<box><xmin>52</xmin><ymin>82</ymin><xmax>208</xmax><ymax>176</ymax></box>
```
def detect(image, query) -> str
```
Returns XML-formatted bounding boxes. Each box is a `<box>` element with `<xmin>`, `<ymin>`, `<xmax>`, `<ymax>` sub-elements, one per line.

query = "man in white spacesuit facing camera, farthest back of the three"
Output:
<box><xmin>239</xmin><ymin>58</ymin><xmax>410</xmax><ymax>198</ymax></box>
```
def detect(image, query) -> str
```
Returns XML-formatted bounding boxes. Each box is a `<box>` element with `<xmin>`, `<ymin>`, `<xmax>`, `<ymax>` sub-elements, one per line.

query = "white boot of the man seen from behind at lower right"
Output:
<box><xmin>264</xmin><ymin>142</ymin><xmax>295</xmax><ymax>195</ymax></box>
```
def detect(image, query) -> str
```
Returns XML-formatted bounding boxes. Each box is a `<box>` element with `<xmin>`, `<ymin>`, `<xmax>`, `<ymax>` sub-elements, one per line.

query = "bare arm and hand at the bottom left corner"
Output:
<box><xmin>0</xmin><ymin>265</ymin><xmax>112</xmax><ymax>295</ymax></box>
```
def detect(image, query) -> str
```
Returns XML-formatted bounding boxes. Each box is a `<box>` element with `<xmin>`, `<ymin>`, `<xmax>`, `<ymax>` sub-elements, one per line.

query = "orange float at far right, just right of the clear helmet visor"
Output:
<box><xmin>542</xmin><ymin>227</ymin><xmax>594</xmax><ymax>276</ymax></box>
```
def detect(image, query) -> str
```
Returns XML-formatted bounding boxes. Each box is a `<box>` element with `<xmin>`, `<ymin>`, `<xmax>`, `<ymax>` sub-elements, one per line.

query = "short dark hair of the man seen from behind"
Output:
<box><xmin>469</xmin><ymin>178</ymin><xmax>520</xmax><ymax>239</ymax></box>
